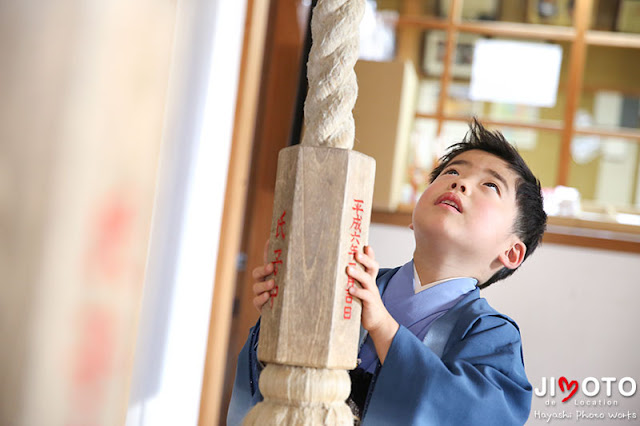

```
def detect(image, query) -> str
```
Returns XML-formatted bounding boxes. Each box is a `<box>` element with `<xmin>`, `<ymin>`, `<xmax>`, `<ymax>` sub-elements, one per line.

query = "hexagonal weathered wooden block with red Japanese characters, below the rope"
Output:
<box><xmin>258</xmin><ymin>146</ymin><xmax>375</xmax><ymax>369</ymax></box>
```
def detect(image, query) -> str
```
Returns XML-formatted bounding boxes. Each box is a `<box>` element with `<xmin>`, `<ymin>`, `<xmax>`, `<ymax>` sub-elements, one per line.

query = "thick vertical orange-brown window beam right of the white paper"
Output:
<box><xmin>556</xmin><ymin>0</ymin><xmax>593</xmax><ymax>185</ymax></box>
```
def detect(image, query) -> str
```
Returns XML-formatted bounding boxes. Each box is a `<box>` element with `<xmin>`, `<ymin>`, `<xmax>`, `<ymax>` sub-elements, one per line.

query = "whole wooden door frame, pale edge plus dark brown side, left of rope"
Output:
<box><xmin>199</xmin><ymin>0</ymin><xmax>309</xmax><ymax>426</ymax></box>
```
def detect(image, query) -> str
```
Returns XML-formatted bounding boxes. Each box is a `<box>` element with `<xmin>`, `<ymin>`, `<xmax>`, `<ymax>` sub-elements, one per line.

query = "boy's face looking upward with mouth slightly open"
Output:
<box><xmin>413</xmin><ymin>150</ymin><xmax>524</xmax><ymax>267</ymax></box>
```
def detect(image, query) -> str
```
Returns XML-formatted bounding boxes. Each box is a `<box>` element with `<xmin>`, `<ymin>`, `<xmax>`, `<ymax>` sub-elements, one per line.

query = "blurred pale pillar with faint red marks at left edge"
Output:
<box><xmin>9</xmin><ymin>0</ymin><xmax>176</xmax><ymax>426</ymax></box>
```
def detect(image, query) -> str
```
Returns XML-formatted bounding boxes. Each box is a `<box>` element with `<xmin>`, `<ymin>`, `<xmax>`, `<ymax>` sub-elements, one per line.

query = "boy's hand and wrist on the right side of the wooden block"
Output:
<box><xmin>347</xmin><ymin>246</ymin><xmax>400</xmax><ymax>363</ymax></box>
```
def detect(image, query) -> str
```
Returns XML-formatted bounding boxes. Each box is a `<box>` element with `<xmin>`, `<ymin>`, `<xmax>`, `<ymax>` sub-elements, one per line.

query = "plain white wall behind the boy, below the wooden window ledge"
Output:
<box><xmin>369</xmin><ymin>225</ymin><xmax>640</xmax><ymax>424</ymax></box>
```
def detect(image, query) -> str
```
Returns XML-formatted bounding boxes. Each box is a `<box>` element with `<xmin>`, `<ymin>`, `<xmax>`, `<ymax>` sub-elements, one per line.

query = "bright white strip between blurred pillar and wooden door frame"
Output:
<box><xmin>127</xmin><ymin>0</ymin><xmax>246</xmax><ymax>426</ymax></box>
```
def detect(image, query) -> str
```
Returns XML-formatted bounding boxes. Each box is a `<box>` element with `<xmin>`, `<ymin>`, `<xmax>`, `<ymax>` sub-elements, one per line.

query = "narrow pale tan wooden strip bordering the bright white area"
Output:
<box><xmin>198</xmin><ymin>0</ymin><xmax>269</xmax><ymax>426</ymax></box>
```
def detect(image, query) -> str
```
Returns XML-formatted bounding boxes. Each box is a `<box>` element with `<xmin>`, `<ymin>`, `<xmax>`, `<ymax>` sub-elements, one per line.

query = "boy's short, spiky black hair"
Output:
<box><xmin>429</xmin><ymin>118</ymin><xmax>547</xmax><ymax>288</ymax></box>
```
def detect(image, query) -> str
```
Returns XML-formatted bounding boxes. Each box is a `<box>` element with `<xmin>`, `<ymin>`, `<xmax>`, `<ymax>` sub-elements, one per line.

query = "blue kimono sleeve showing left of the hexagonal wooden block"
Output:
<box><xmin>227</xmin><ymin>320</ymin><xmax>263</xmax><ymax>426</ymax></box>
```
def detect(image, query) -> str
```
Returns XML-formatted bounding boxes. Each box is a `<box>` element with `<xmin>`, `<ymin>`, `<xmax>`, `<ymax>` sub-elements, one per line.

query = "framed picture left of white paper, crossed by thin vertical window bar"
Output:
<box><xmin>422</xmin><ymin>31</ymin><xmax>482</xmax><ymax>78</ymax></box>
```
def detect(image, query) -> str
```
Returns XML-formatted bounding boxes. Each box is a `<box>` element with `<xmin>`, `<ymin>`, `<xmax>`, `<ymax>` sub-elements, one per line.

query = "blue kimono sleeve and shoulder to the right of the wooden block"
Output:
<box><xmin>363</xmin><ymin>315</ymin><xmax>531</xmax><ymax>426</ymax></box>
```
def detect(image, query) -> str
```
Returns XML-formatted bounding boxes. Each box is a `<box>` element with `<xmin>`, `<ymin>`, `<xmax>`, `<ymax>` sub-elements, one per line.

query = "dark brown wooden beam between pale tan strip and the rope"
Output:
<box><xmin>219</xmin><ymin>0</ymin><xmax>309</xmax><ymax>424</ymax></box>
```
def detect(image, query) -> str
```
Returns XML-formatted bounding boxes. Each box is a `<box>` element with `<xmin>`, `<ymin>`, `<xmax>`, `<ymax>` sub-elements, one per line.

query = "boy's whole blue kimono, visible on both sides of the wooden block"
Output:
<box><xmin>227</xmin><ymin>268</ymin><xmax>532</xmax><ymax>426</ymax></box>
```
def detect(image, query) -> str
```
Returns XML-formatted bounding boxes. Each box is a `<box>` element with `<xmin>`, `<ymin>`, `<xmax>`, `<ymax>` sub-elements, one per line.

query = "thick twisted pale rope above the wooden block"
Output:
<box><xmin>302</xmin><ymin>0</ymin><xmax>364</xmax><ymax>149</ymax></box>
